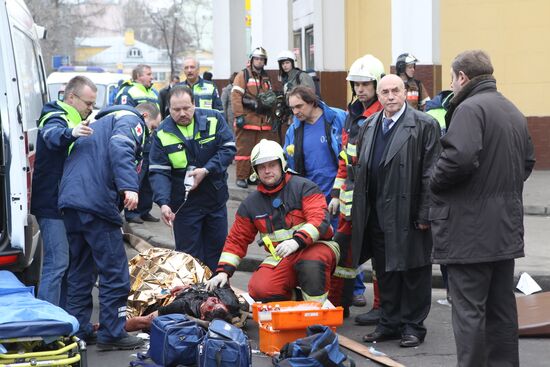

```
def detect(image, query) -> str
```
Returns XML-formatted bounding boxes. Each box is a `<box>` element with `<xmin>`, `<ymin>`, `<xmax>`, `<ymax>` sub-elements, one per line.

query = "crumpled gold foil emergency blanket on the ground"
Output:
<box><xmin>126</xmin><ymin>247</ymin><xmax>212</xmax><ymax>318</ymax></box>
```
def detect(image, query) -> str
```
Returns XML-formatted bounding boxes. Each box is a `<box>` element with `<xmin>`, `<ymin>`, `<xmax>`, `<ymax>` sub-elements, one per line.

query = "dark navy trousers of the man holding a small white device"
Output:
<box><xmin>174</xmin><ymin>205</ymin><xmax>227</xmax><ymax>272</ymax></box>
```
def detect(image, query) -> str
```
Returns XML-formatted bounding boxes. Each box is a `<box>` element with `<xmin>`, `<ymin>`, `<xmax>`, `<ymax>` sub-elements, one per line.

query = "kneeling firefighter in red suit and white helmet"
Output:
<box><xmin>207</xmin><ymin>139</ymin><xmax>340</xmax><ymax>302</ymax></box>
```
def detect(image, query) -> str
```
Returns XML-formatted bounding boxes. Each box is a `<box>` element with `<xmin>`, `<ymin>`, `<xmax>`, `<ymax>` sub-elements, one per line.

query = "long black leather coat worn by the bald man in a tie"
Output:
<box><xmin>352</xmin><ymin>106</ymin><xmax>440</xmax><ymax>271</ymax></box>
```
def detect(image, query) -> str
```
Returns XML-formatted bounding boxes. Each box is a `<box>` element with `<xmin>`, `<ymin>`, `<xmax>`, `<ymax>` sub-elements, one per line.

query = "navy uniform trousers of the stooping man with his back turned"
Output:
<box><xmin>63</xmin><ymin>209</ymin><xmax>130</xmax><ymax>342</ymax></box>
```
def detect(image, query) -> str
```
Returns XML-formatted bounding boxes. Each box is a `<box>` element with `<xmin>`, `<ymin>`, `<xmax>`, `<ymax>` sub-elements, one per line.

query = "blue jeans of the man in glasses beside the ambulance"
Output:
<box><xmin>36</xmin><ymin>217</ymin><xmax>69</xmax><ymax>307</ymax></box>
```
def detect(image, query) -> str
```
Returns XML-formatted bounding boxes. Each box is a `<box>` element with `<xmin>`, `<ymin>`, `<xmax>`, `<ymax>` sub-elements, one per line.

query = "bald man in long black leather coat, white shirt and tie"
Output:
<box><xmin>352</xmin><ymin>75</ymin><xmax>440</xmax><ymax>347</ymax></box>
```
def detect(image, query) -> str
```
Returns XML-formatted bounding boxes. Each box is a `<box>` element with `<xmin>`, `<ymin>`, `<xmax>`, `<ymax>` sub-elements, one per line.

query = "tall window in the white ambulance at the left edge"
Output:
<box><xmin>13</xmin><ymin>28</ymin><xmax>43</xmax><ymax>130</ymax></box>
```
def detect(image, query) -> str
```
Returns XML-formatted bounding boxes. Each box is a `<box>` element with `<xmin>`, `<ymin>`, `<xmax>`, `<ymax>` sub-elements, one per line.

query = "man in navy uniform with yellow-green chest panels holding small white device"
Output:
<box><xmin>149</xmin><ymin>85</ymin><xmax>237</xmax><ymax>270</ymax></box>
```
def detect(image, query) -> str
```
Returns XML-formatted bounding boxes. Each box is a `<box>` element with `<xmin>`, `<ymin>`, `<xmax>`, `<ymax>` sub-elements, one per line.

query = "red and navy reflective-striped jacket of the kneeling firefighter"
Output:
<box><xmin>217</xmin><ymin>173</ymin><xmax>340</xmax><ymax>275</ymax></box>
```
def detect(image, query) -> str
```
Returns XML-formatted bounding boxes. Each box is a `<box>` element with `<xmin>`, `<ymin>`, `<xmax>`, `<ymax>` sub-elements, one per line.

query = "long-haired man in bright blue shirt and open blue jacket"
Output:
<box><xmin>284</xmin><ymin>86</ymin><xmax>346</xmax><ymax>229</ymax></box>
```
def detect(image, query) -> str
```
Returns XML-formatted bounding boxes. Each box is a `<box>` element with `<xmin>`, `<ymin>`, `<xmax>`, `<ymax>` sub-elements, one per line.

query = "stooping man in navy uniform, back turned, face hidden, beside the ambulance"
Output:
<box><xmin>59</xmin><ymin>103</ymin><xmax>158</xmax><ymax>350</ymax></box>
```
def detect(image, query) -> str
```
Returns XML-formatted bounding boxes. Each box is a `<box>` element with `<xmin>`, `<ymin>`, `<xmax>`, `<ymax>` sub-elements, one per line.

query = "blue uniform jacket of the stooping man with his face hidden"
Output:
<box><xmin>59</xmin><ymin>106</ymin><xmax>146</xmax><ymax>226</ymax></box>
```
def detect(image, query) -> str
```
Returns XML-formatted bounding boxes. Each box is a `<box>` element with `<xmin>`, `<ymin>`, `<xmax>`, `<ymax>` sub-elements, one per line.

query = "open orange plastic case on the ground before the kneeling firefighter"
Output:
<box><xmin>252</xmin><ymin>301</ymin><xmax>344</xmax><ymax>355</ymax></box>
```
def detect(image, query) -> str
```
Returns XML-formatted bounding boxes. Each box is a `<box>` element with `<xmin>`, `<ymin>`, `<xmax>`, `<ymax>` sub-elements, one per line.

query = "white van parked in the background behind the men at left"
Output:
<box><xmin>46</xmin><ymin>66</ymin><xmax>130</xmax><ymax>112</ymax></box>
